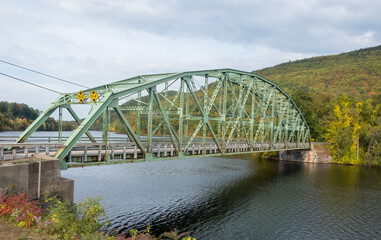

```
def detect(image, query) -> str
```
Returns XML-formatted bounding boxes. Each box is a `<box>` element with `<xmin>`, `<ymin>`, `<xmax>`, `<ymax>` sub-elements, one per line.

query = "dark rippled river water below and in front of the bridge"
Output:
<box><xmin>61</xmin><ymin>155</ymin><xmax>381</xmax><ymax>239</ymax></box>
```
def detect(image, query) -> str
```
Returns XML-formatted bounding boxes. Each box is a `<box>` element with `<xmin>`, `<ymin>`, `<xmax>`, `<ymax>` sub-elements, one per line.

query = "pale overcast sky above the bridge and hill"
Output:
<box><xmin>0</xmin><ymin>0</ymin><xmax>381</xmax><ymax>114</ymax></box>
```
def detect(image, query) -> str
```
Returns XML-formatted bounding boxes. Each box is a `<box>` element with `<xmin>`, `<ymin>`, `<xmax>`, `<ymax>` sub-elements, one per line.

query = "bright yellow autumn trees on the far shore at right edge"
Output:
<box><xmin>324</xmin><ymin>96</ymin><xmax>381</xmax><ymax>165</ymax></box>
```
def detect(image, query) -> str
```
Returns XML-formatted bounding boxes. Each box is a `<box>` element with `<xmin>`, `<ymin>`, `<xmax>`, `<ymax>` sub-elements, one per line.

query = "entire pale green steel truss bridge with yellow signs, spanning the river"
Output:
<box><xmin>15</xmin><ymin>69</ymin><xmax>311</xmax><ymax>168</ymax></box>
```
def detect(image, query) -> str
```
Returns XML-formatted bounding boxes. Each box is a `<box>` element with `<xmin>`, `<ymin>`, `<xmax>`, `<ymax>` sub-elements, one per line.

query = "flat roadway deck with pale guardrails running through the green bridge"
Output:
<box><xmin>0</xmin><ymin>142</ymin><xmax>308</xmax><ymax>165</ymax></box>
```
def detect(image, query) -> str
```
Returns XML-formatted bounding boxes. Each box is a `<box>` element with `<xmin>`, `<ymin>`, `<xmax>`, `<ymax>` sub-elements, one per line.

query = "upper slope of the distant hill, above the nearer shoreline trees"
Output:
<box><xmin>254</xmin><ymin>45</ymin><xmax>381</xmax><ymax>99</ymax></box>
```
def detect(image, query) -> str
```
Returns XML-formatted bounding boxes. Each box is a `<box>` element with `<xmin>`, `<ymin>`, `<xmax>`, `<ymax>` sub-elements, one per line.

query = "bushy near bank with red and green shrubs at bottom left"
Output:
<box><xmin>0</xmin><ymin>190</ymin><xmax>195</xmax><ymax>240</ymax></box>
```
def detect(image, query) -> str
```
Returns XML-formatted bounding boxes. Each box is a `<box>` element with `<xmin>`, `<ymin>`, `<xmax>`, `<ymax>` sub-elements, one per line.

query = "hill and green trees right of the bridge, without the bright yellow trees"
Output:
<box><xmin>254</xmin><ymin>45</ymin><xmax>381</xmax><ymax>140</ymax></box>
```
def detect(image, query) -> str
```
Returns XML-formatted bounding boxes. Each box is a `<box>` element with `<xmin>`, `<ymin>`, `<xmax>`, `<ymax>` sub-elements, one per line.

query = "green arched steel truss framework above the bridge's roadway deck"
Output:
<box><xmin>16</xmin><ymin>69</ymin><xmax>310</xmax><ymax>168</ymax></box>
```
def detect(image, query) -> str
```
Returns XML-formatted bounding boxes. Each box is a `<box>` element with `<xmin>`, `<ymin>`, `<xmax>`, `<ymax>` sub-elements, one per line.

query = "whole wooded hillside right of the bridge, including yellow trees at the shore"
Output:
<box><xmin>255</xmin><ymin>45</ymin><xmax>381</xmax><ymax>165</ymax></box>
